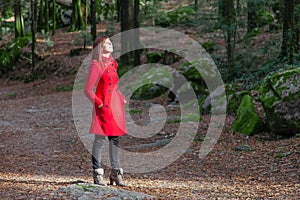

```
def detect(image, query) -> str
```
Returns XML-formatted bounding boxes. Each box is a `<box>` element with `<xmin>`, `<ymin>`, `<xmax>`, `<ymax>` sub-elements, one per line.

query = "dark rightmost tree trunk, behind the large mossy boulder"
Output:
<box><xmin>279</xmin><ymin>0</ymin><xmax>296</xmax><ymax>64</ymax></box>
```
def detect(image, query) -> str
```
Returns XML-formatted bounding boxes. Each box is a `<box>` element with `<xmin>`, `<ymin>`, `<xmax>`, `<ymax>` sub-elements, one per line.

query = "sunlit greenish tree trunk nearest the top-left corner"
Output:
<box><xmin>14</xmin><ymin>0</ymin><xmax>25</xmax><ymax>38</ymax></box>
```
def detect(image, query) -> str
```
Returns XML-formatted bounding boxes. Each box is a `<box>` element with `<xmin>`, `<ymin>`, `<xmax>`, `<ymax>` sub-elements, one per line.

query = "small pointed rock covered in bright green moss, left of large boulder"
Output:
<box><xmin>232</xmin><ymin>95</ymin><xmax>262</xmax><ymax>135</ymax></box>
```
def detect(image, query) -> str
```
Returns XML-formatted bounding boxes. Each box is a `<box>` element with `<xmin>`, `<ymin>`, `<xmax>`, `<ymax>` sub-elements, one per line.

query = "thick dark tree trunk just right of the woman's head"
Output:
<box><xmin>121</xmin><ymin>0</ymin><xmax>140</xmax><ymax>65</ymax></box>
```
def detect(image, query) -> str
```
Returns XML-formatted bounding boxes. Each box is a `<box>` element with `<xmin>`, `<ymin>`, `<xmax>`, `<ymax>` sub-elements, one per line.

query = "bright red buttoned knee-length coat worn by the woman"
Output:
<box><xmin>84</xmin><ymin>56</ymin><xmax>126</xmax><ymax>136</ymax></box>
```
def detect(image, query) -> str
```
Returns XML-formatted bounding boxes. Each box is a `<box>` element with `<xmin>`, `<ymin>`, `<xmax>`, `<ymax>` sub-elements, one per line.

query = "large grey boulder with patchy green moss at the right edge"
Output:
<box><xmin>259</xmin><ymin>68</ymin><xmax>300</xmax><ymax>136</ymax></box>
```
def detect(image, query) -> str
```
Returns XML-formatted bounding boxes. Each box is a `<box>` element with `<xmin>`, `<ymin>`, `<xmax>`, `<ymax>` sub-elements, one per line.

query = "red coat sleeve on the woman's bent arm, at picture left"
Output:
<box><xmin>84</xmin><ymin>62</ymin><xmax>103</xmax><ymax>107</ymax></box>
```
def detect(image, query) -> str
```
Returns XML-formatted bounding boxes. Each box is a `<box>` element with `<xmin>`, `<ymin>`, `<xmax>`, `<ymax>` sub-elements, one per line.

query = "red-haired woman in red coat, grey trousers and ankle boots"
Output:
<box><xmin>84</xmin><ymin>37</ymin><xmax>126</xmax><ymax>186</ymax></box>
